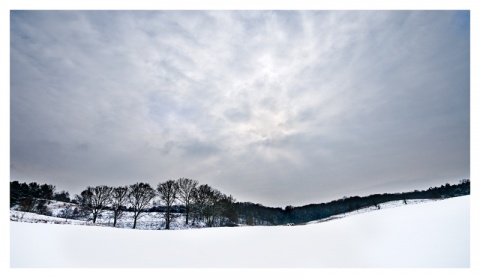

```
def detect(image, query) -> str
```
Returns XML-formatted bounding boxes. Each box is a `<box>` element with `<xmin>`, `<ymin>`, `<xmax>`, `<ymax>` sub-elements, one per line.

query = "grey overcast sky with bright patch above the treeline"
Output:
<box><xmin>10</xmin><ymin>11</ymin><xmax>470</xmax><ymax>207</ymax></box>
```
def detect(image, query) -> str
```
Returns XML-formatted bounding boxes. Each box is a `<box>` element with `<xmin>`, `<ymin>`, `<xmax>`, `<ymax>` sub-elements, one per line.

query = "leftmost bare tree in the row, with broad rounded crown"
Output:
<box><xmin>76</xmin><ymin>185</ymin><xmax>112</xmax><ymax>223</ymax></box>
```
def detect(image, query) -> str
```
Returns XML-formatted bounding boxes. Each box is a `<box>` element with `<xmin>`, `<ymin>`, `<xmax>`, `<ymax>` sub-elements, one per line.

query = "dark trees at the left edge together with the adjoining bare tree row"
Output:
<box><xmin>10</xmin><ymin>178</ymin><xmax>237</xmax><ymax>229</ymax></box>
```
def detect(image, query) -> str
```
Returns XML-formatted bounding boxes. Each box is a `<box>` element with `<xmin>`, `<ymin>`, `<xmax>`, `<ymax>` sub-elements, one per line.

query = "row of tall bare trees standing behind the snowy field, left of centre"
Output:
<box><xmin>75</xmin><ymin>178</ymin><xmax>237</xmax><ymax>229</ymax></box>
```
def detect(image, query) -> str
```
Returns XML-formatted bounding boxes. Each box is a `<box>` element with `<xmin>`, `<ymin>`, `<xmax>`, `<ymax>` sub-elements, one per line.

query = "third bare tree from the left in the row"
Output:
<box><xmin>128</xmin><ymin>182</ymin><xmax>156</xmax><ymax>229</ymax></box>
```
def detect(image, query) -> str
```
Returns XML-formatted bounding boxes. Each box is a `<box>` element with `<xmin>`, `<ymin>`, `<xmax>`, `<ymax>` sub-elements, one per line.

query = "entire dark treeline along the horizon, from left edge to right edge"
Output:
<box><xmin>10</xmin><ymin>178</ymin><xmax>470</xmax><ymax>229</ymax></box>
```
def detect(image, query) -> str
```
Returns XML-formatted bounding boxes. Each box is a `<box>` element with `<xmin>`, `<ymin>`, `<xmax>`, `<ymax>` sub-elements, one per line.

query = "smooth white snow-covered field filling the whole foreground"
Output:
<box><xmin>10</xmin><ymin>196</ymin><xmax>470</xmax><ymax>268</ymax></box>
